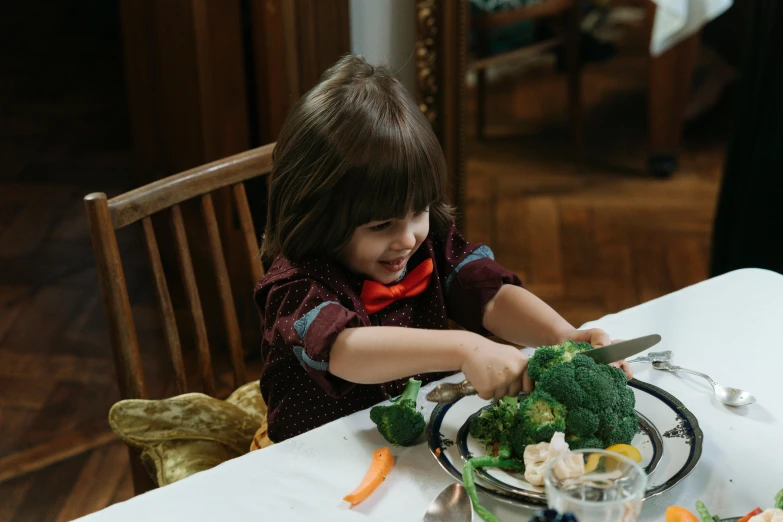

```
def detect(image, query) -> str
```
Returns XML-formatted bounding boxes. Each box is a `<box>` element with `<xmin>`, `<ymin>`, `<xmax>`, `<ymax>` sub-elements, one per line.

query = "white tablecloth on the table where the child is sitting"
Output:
<box><xmin>78</xmin><ymin>270</ymin><xmax>783</xmax><ymax>522</ymax></box>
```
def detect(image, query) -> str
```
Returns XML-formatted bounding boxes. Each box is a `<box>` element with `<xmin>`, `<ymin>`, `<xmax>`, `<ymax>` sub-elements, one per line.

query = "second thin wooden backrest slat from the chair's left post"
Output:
<box><xmin>171</xmin><ymin>201</ymin><xmax>215</xmax><ymax>396</ymax></box>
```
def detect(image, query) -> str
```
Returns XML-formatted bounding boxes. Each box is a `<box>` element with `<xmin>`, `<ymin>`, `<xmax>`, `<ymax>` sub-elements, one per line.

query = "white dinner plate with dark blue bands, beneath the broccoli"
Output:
<box><xmin>427</xmin><ymin>379</ymin><xmax>704</xmax><ymax>508</ymax></box>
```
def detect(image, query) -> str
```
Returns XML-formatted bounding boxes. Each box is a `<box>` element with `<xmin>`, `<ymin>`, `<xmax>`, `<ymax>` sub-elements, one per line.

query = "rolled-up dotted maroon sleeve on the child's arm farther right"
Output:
<box><xmin>434</xmin><ymin>225</ymin><xmax>524</xmax><ymax>335</ymax></box>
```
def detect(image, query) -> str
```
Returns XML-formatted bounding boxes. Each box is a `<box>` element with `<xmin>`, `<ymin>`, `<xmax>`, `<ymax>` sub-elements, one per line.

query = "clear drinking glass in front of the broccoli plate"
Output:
<box><xmin>544</xmin><ymin>449</ymin><xmax>647</xmax><ymax>522</ymax></box>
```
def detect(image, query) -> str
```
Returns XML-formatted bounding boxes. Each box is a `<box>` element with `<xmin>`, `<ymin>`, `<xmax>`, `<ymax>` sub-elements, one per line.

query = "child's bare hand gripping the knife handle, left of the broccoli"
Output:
<box><xmin>461</xmin><ymin>336</ymin><xmax>533</xmax><ymax>399</ymax></box>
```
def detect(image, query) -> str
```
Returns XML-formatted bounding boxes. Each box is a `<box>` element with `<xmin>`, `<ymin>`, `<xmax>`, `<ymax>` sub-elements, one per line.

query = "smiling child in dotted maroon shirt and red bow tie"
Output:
<box><xmin>255</xmin><ymin>56</ymin><xmax>632</xmax><ymax>442</ymax></box>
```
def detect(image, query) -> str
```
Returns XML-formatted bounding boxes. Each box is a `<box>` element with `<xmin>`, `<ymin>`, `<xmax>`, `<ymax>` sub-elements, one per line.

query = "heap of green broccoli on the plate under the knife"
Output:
<box><xmin>470</xmin><ymin>341</ymin><xmax>639</xmax><ymax>459</ymax></box>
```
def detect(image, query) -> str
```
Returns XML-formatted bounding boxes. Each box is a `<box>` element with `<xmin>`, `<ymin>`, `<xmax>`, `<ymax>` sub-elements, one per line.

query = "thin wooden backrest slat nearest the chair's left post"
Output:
<box><xmin>141</xmin><ymin>216</ymin><xmax>188</xmax><ymax>394</ymax></box>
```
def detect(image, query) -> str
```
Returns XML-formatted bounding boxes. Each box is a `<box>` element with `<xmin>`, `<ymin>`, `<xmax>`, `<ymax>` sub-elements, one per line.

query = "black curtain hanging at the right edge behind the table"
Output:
<box><xmin>710</xmin><ymin>0</ymin><xmax>783</xmax><ymax>276</ymax></box>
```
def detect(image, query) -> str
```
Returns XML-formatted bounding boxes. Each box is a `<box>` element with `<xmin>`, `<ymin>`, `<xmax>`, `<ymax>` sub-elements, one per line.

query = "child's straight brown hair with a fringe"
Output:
<box><xmin>262</xmin><ymin>55</ymin><xmax>453</xmax><ymax>262</ymax></box>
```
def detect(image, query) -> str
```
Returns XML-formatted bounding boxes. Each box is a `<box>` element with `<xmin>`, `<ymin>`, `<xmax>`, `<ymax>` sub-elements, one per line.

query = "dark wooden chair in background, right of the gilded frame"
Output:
<box><xmin>467</xmin><ymin>0</ymin><xmax>582</xmax><ymax>148</ymax></box>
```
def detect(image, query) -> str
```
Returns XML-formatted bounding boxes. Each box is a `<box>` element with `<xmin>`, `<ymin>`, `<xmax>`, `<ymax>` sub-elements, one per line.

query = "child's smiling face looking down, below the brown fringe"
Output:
<box><xmin>339</xmin><ymin>209</ymin><xmax>430</xmax><ymax>284</ymax></box>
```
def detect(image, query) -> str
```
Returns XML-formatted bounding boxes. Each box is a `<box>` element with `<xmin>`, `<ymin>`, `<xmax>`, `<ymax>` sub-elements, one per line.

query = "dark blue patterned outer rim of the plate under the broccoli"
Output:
<box><xmin>426</xmin><ymin>378</ymin><xmax>704</xmax><ymax>508</ymax></box>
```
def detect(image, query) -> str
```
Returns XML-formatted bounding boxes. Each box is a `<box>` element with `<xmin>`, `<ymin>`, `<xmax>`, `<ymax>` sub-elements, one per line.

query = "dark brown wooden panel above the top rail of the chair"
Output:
<box><xmin>120</xmin><ymin>0</ymin><xmax>250</xmax><ymax>179</ymax></box>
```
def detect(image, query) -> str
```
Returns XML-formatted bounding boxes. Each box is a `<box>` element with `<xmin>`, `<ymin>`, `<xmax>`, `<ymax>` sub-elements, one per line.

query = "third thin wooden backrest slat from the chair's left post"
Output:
<box><xmin>201</xmin><ymin>194</ymin><xmax>247</xmax><ymax>388</ymax></box>
